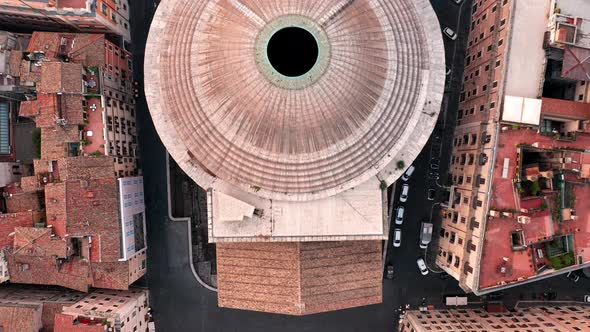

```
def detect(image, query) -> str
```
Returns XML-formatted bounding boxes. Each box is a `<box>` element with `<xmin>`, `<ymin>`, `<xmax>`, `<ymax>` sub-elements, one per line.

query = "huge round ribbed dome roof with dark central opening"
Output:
<box><xmin>145</xmin><ymin>0</ymin><xmax>444</xmax><ymax>200</ymax></box>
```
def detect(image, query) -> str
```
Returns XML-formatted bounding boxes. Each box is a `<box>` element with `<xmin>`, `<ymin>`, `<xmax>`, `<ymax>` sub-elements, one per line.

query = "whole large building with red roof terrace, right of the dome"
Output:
<box><xmin>437</xmin><ymin>0</ymin><xmax>590</xmax><ymax>294</ymax></box>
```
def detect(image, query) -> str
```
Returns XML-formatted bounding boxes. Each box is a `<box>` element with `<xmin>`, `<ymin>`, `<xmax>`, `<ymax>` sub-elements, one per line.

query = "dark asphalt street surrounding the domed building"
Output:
<box><xmin>131</xmin><ymin>0</ymin><xmax>590</xmax><ymax>332</ymax></box>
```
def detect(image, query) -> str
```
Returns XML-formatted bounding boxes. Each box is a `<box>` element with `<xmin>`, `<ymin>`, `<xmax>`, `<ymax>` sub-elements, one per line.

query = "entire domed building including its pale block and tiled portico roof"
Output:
<box><xmin>144</xmin><ymin>0</ymin><xmax>445</xmax><ymax>315</ymax></box>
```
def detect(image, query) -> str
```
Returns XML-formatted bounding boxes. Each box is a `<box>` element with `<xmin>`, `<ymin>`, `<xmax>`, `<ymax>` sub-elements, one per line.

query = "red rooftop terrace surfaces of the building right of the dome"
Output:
<box><xmin>479</xmin><ymin>122</ymin><xmax>590</xmax><ymax>290</ymax></box>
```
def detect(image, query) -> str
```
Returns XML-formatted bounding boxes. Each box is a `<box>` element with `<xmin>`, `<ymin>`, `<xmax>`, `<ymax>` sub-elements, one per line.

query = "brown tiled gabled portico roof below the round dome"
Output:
<box><xmin>217</xmin><ymin>241</ymin><xmax>382</xmax><ymax>315</ymax></box>
